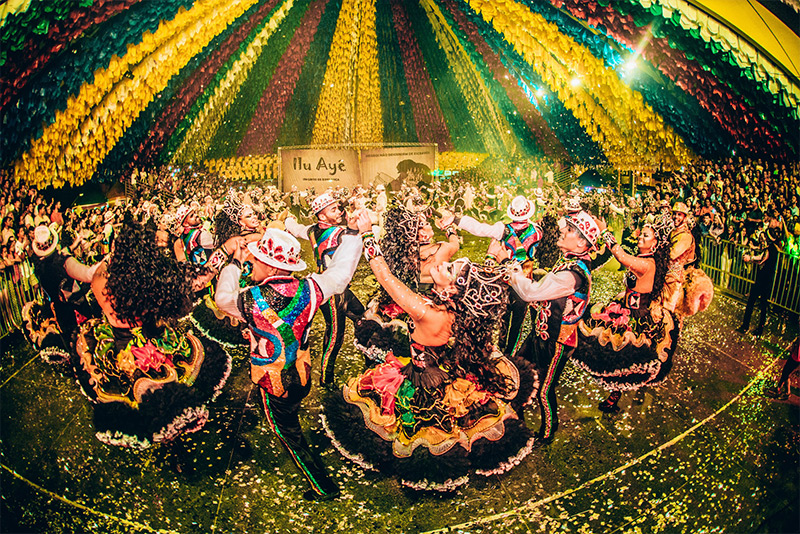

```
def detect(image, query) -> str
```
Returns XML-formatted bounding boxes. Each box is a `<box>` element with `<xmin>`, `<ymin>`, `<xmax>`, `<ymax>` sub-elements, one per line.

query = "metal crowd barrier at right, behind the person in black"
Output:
<box><xmin>700</xmin><ymin>236</ymin><xmax>800</xmax><ymax>313</ymax></box>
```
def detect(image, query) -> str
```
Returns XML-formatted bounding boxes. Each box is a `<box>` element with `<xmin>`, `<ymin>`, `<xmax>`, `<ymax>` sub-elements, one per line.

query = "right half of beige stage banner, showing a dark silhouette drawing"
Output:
<box><xmin>361</xmin><ymin>145</ymin><xmax>436</xmax><ymax>191</ymax></box>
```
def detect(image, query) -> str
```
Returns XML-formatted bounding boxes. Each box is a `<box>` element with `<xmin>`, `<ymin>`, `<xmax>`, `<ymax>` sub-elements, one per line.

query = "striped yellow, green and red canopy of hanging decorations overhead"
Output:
<box><xmin>0</xmin><ymin>0</ymin><xmax>800</xmax><ymax>186</ymax></box>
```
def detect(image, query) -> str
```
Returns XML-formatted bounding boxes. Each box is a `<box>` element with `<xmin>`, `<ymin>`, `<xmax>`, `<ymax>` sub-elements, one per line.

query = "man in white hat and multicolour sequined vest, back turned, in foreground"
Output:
<box><xmin>216</xmin><ymin>228</ymin><xmax>362</xmax><ymax>500</ymax></box>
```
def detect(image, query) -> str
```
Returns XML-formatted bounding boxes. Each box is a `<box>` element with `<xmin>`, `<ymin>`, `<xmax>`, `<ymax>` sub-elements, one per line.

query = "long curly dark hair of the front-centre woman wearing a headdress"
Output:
<box><xmin>435</xmin><ymin>262</ymin><xmax>512</xmax><ymax>395</ymax></box>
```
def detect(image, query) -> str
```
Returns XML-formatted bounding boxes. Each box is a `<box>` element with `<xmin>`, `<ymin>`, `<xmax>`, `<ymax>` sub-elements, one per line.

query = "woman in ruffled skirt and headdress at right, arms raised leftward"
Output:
<box><xmin>572</xmin><ymin>215</ymin><xmax>678</xmax><ymax>413</ymax></box>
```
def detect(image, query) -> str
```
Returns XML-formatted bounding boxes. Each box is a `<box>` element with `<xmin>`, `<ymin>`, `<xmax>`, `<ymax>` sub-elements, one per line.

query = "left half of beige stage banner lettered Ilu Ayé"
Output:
<box><xmin>278</xmin><ymin>148</ymin><xmax>361</xmax><ymax>194</ymax></box>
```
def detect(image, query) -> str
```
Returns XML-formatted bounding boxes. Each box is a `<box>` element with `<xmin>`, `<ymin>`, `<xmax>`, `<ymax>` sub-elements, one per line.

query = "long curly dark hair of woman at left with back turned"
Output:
<box><xmin>106</xmin><ymin>212</ymin><xmax>192</xmax><ymax>337</ymax></box>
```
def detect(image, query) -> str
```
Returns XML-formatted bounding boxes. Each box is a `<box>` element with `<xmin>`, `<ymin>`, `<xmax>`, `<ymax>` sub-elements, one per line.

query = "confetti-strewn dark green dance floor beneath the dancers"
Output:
<box><xmin>0</xmin><ymin>239</ymin><xmax>800</xmax><ymax>533</ymax></box>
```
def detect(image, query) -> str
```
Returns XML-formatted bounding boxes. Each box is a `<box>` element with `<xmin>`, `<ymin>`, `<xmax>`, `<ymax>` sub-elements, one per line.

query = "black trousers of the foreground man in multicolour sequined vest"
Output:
<box><xmin>259</xmin><ymin>382</ymin><xmax>339</xmax><ymax>495</ymax></box>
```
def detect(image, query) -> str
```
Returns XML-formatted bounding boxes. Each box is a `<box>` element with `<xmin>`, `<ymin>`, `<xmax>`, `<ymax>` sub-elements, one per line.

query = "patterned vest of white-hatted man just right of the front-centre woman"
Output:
<box><xmin>531</xmin><ymin>255</ymin><xmax>592</xmax><ymax>347</ymax></box>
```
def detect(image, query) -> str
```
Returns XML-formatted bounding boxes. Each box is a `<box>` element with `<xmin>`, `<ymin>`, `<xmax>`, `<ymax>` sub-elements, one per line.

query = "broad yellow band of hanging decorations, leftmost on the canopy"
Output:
<box><xmin>15</xmin><ymin>0</ymin><xmax>262</xmax><ymax>191</ymax></box>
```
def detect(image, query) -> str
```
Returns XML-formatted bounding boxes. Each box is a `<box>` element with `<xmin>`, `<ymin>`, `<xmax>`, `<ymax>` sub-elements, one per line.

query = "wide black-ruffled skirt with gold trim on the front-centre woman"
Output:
<box><xmin>323</xmin><ymin>352</ymin><xmax>536</xmax><ymax>491</ymax></box>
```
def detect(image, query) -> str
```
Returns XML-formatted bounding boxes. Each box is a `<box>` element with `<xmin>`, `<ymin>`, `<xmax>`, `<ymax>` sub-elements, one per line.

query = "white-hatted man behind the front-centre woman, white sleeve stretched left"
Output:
<box><xmin>442</xmin><ymin>195</ymin><xmax>542</xmax><ymax>354</ymax></box>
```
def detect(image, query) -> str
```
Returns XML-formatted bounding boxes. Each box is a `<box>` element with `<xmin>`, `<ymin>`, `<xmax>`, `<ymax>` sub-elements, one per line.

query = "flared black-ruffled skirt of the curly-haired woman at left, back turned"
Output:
<box><xmin>73</xmin><ymin>319</ymin><xmax>231</xmax><ymax>449</ymax></box>
